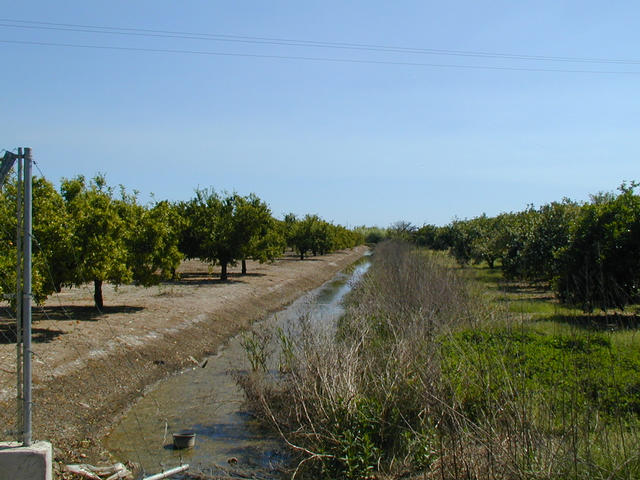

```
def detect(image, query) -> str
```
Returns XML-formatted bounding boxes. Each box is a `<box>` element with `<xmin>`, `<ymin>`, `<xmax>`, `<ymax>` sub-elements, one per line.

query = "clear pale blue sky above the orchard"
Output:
<box><xmin>0</xmin><ymin>0</ymin><xmax>640</xmax><ymax>226</ymax></box>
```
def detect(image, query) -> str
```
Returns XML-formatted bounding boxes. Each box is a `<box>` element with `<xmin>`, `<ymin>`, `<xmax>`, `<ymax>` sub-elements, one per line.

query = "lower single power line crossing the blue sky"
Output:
<box><xmin>0</xmin><ymin>39</ymin><xmax>640</xmax><ymax>75</ymax></box>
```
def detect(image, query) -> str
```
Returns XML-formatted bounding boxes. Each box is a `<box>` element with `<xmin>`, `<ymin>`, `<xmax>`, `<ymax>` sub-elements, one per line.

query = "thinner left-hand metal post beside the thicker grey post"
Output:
<box><xmin>16</xmin><ymin>148</ymin><xmax>24</xmax><ymax>441</ymax></box>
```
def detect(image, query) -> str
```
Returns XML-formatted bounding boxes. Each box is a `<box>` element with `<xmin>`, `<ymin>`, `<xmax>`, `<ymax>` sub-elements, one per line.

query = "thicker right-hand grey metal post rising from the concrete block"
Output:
<box><xmin>22</xmin><ymin>148</ymin><xmax>32</xmax><ymax>447</ymax></box>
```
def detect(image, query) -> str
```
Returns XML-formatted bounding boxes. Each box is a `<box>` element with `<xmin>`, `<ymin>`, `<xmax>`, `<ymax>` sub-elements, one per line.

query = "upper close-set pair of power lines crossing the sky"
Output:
<box><xmin>0</xmin><ymin>18</ymin><xmax>640</xmax><ymax>65</ymax></box>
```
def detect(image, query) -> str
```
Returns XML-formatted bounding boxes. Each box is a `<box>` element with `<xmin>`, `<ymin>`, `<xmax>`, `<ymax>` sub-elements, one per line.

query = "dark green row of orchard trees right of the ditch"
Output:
<box><xmin>357</xmin><ymin>182</ymin><xmax>640</xmax><ymax>311</ymax></box>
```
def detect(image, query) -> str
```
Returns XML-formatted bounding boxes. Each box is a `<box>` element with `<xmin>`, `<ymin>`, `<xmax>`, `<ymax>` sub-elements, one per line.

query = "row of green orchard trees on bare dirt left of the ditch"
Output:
<box><xmin>0</xmin><ymin>175</ymin><xmax>364</xmax><ymax>308</ymax></box>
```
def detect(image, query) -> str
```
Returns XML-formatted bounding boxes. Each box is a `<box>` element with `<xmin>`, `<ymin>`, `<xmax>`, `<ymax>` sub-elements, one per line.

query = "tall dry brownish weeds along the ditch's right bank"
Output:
<box><xmin>243</xmin><ymin>243</ymin><xmax>489</xmax><ymax>478</ymax></box>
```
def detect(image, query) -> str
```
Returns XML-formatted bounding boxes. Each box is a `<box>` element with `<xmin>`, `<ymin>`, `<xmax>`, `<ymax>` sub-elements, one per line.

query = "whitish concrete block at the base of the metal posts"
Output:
<box><xmin>0</xmin><ymin>442</ymin><xmax>53</xmax><ymax>480</ymax></box>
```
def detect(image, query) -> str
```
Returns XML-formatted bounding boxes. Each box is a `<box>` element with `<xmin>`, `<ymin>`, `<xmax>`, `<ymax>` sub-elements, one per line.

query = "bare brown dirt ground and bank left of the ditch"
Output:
<box><xmin>0</xmin><ymin>247</ymin><xmax>366</xmax><ymax>470</ymax></box>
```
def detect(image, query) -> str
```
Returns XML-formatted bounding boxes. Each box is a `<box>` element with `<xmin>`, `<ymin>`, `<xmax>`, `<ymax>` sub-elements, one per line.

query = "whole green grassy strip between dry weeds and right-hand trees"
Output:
<box><xmin>440</xmin><ymin>265</ymin><xmax>640</xmax><ymax>480</ymax></box>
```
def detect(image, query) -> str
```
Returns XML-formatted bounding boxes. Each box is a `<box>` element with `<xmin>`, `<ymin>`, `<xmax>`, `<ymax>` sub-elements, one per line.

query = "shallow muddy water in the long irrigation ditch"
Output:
<box><xmin>106</xmin><ymin>257</ymin><xmax>370</xmax><ymax>479</ymax></box>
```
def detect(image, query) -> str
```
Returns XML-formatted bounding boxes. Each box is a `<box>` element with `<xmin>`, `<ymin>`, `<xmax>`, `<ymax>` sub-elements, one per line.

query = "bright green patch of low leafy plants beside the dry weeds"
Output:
<box><xmin>443</xmin><ymin>326</ymin><xmax>640</xmax><ymax>422</ymax></box>
